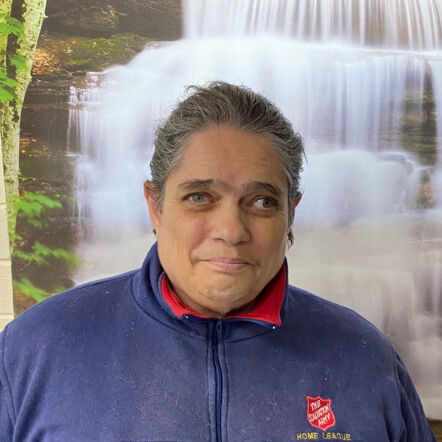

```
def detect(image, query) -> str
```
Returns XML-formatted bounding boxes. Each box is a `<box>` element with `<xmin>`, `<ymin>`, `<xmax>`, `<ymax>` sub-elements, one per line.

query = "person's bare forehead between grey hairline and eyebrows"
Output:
<box><xmin>168</xmin><ymin>126</ymin><xmax>287</xmax><ymax>193</ymax></box>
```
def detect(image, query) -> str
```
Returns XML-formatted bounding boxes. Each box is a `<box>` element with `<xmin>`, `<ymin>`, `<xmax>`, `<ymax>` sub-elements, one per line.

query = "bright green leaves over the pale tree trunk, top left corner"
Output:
<box><xmin>0</xmin><ymin>14</ymin><xmax>28</xmax><ymax>103</ymax></box>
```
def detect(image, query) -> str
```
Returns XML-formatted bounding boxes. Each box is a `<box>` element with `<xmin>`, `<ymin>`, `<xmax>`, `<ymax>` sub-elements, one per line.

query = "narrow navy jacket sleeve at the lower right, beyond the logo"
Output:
<box><xmin>394</xmin><ymin>352</ymin><xmax>436</xmax><ymax>442</ymax></box>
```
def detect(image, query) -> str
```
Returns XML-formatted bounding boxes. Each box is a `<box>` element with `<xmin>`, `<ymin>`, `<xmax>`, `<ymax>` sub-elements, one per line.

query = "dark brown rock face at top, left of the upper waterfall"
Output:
<box><xmin>43</xmin><ymin>0</ymin><xmax>182</xmax><ymax>40</ymax></box>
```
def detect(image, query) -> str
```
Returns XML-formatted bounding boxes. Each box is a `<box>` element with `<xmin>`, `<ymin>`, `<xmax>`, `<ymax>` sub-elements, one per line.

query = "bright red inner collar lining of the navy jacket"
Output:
<box><xmin>161</xmin><ymin>263</ymin><xmax>287</xmax><ymax>326</ymax></box>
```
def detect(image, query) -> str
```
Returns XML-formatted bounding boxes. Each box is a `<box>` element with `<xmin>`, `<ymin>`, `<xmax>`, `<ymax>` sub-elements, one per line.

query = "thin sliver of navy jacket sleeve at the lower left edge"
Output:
<box><xmin>0</xmin><ymin>330</ymin><xmax>14</xmax><ymax>442</ymax></box>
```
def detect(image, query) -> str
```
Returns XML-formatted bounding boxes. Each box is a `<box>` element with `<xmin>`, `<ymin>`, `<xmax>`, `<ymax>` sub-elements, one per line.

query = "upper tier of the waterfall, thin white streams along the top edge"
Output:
<box><xmin>184</xmin><ymin>0</ymin><xmax>442</xmax><ymax>50</ymax></box>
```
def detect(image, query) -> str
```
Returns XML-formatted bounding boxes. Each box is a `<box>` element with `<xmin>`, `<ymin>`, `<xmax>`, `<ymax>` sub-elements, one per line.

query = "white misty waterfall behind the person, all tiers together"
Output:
<box><xmin>69</xmin><ymin>0</ymin><xmax>442</xmax><ymax>418</ymax></box>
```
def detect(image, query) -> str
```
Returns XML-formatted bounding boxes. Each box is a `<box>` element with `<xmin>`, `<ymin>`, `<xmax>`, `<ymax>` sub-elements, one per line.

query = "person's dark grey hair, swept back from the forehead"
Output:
<box><xmin>149</xmin><ymin>81</ymin><xmax>305</xmax><ymax>245</ymax></box>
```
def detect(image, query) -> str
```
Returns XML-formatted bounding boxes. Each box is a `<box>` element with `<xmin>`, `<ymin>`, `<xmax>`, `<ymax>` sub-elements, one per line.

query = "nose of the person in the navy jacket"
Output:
<box><xmin>212</xmin><ymin>203</ymin><xmax>251</xmax><ymax>246</ymax></box>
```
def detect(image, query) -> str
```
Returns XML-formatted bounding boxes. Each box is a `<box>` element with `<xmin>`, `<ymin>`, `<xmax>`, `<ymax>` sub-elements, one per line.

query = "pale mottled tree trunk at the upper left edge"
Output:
<box><xmin>0</xmin><ymin>0</ymin><xmax>46</xmax><ymax>237</ymax></box>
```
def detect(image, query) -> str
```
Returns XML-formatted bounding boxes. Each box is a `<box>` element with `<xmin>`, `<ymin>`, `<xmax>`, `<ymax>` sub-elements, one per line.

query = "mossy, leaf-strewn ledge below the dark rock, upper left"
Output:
<box><xmin>39</xmin><ymin>34</ymin><xmax>150</xmax><ymax>72</ymax></box>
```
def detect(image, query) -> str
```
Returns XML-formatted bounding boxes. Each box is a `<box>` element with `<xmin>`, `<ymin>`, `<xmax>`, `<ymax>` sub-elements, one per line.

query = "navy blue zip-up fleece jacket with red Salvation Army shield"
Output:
<box><xmin>0</xmin><ymin>246</ymin><xmax>434</xmax><ymax>442</ymax></box>
